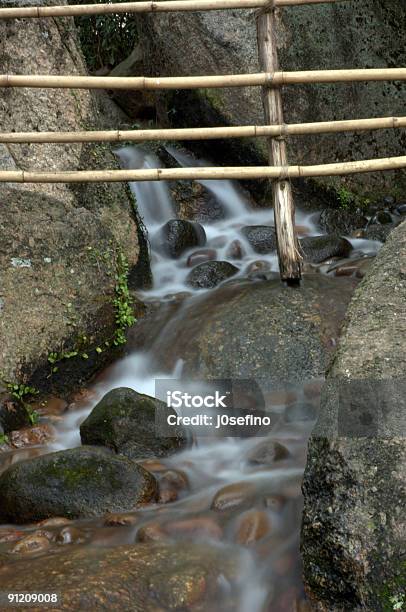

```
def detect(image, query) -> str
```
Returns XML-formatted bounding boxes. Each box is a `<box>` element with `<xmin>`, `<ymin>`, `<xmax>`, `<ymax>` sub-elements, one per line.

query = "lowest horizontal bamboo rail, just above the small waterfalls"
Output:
<box><xmin>0</xmin><ymin>155</ymin><xmax>406</xmax><ymax>183</ymax></box>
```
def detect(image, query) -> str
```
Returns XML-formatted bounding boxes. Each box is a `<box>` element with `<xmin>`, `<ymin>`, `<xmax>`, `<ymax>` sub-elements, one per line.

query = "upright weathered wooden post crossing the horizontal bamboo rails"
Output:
<box><xmin>257</xmin><ymin>4</ymin><xmax>302</xmax><ymax>283</ymax></box>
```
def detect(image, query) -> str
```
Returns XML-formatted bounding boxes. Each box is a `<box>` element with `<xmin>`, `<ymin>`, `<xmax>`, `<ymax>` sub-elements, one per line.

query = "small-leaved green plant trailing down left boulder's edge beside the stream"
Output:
<box><xmin>113</xmin><ymin>251</ymin><xmax>136</xmax><ymax>346</ymax></box>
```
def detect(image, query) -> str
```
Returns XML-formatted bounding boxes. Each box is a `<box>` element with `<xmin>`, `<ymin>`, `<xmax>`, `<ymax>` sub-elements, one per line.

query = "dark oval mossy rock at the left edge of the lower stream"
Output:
<box><xmin>0</xmin><ymin>447</ymin><xmax>157</xmax><ymax>523</ymax></box>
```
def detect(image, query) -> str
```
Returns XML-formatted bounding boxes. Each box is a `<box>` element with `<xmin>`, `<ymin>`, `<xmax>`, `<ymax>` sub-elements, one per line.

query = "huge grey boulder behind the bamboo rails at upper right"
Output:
<box><xmin>139</xmin><ymin>0</ymin><xmax>406</xmax><ymax>192</ymax></box>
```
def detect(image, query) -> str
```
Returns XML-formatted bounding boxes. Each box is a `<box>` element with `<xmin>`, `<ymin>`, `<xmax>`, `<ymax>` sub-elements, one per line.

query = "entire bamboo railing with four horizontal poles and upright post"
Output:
<box><xmin>0</xmin><ymin>0</ymin><xmax>406</xmax><ymax>282</ymax></box>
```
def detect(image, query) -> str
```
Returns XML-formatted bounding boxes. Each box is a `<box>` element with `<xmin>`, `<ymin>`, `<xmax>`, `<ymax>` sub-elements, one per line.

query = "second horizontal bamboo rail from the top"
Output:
<box><xmin>0</xmin><ymin>68</ymin><xmax>406</xmax><ymax>90</ymax></box>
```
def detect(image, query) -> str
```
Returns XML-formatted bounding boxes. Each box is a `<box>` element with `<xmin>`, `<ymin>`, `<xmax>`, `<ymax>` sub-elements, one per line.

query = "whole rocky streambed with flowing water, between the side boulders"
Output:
<box><xmin>0</xmin><ymin>150</ymin><xmax>401</xmax><ymax>612</ymax></box>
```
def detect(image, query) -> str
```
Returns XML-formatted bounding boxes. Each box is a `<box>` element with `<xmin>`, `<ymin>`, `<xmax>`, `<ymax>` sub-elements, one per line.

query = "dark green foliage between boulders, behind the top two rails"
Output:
<box><xmin>75</xmin><ymin>0</ymin><xmax>137</xmax><ymax>71</ymax></box>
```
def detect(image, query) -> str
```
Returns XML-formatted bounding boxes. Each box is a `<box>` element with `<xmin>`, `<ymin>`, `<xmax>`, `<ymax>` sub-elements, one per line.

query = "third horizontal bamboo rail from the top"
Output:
<box><xmin>0</xmin><ymin>117</ymin><xmax>406</xmax><ymax>144</ymax></box>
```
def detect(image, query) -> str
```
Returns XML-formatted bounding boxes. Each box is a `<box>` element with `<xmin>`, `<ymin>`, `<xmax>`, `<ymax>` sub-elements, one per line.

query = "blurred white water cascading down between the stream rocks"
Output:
<box><xmin>49</xmin><ymin>147</ymin><xmax>379</xmax><ymax>612</ymax></box>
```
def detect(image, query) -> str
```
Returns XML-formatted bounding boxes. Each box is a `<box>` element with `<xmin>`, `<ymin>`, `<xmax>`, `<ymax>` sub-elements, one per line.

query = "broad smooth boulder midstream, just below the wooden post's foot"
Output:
<box><xmin>136</xmin><ymin>274</ymin><xmax>356</xmax><ymax>382</ymax></box>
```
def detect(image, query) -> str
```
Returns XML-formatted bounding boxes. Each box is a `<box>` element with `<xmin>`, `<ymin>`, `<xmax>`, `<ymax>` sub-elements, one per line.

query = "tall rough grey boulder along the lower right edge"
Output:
<box><xmin>302</xmin><ymin>223</ymin><xmax>406</xmax><ymax>611</ymax></box>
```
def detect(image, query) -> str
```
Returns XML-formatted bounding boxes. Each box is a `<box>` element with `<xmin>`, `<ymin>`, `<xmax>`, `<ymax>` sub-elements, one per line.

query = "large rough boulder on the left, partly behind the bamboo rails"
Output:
<box><xmin>0</xmin><ymin>1</ymin><xmax>150</xmax><ymax>383</ymax></box>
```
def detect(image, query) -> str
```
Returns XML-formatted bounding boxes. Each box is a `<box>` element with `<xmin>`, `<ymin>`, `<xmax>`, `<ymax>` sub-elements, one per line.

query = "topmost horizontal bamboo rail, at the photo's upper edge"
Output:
<box><xmin>0</xmin><ymin>0</ymin><xmax>348</xmax><ymax>19</ymax></box>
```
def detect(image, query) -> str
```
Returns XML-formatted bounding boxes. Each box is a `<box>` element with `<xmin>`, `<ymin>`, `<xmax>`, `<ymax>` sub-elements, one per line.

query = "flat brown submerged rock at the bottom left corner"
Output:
<box><xmin>0</xmin><ymin>542</ymin><xmax>238</xmax><ymax>612</ymax></box>
